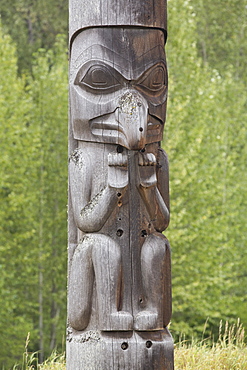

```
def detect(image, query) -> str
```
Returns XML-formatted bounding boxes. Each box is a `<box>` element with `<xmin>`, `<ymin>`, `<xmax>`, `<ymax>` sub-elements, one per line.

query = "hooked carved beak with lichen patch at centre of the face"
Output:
<box><xmin>115</xmin><ymin>91</ymin><xmax>148</xmax><ymax>149</ymax></box>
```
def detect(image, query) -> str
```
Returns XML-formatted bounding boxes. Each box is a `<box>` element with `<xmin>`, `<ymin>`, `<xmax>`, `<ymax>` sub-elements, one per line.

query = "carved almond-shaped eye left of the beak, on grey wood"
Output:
<box><xmin>79</xmin><ymin>65</ymin><xmax>120</xmax><ymax>93</ymax></box>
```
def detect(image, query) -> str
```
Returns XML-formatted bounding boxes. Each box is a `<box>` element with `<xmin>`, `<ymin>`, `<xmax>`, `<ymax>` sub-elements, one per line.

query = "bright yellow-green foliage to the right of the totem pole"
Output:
<box><xmin>164</xmin><ymin>0</ymin><xmax>247</xmax><ymax>335</ymax></box>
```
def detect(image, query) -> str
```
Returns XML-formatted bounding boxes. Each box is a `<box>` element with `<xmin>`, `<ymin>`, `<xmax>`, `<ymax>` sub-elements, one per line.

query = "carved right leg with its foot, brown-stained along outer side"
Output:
<box><xmin>134</xmin><ymin>233</ymin><xmax>171</xmax><ymax>331</ymax></box>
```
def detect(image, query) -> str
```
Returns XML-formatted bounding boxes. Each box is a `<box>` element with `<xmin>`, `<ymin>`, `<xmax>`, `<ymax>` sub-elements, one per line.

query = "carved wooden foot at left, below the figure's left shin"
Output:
<box><xmin>101</xmin><ymin>311</ymin><xmax>133</xmax><ymax>331</ymax></box>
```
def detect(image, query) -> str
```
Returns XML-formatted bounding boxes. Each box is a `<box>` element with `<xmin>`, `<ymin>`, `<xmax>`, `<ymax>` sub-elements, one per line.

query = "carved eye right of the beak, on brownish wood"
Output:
<box><xmin>138</xmin><ymin>66</ymin><xmax>166</xmax><ymax>92</ymax></box>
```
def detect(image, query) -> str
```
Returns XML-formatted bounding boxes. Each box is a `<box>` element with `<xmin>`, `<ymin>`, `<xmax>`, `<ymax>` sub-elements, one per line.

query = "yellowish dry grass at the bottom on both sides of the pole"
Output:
<box><xmin>13</xmin><ymin>321</ymin><xmax>247</xmax><ymax>370</ymax></box>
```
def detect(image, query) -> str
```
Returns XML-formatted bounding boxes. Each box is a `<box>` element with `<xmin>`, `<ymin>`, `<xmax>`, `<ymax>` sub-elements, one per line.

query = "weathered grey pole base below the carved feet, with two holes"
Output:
<box><xmin>66</xmin><ymin>330</ymin><xmax>174</xmax><ymax>370</ymax></box>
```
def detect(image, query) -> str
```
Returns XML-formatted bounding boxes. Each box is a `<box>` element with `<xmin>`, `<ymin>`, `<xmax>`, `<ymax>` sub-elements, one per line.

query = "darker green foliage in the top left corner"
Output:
<box><xmin>0</xmin><ymin>0</ymin><xmax>68</xmax><ymax>70</ymax></box>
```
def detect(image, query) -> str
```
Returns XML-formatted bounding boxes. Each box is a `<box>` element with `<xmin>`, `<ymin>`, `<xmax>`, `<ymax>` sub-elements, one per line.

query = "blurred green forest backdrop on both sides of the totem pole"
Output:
<box><xmin>0</xmin><ymin>0</ymin><xmax>247</xmax><ymax>369</ymax></box>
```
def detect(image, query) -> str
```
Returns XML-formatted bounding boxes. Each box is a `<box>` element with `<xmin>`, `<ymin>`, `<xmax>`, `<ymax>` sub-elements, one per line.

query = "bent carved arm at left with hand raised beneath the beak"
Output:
<box><xmin>69</xmin><ymin>149</ymin><xmax>128</xmax><ymax>232</ymax></box>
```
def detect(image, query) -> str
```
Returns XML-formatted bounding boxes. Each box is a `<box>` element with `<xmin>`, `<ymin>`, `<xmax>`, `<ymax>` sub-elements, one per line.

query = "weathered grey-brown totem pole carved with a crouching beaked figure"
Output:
<box><xmin>67</xmin><ymin>0</ymin><xmax>173</xmax><ymax>370</ymax></box>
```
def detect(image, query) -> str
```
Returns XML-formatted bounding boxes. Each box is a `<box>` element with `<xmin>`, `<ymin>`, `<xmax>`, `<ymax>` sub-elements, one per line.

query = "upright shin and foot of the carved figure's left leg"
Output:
<box><xmin>92</xmin><ymin>234</ymin><xmax>133</xmax><ymax>331</ymax></box>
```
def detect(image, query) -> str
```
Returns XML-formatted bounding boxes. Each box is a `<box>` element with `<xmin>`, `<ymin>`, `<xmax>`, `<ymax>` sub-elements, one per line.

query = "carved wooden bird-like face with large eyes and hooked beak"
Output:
<box><xmin>70</xmin><ymin>27</ymin><xmax>167</xmax><ymax>149</ymax></box>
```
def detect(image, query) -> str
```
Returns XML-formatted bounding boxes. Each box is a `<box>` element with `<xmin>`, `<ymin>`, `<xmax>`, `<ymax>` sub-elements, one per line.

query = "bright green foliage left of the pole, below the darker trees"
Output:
<box><xmin>0</xmin><ymin>25</ymin><xmax>67</xmax><ymax>368</ymax></box>
